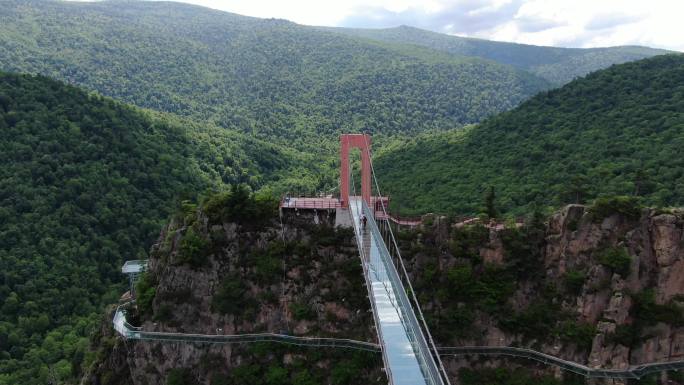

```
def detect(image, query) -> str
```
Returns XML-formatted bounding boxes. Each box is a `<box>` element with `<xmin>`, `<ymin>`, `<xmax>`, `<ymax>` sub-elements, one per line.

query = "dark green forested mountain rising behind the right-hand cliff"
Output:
<box><xmin>376</xmin><ymin>55</ymin><xmax>684</xmax><ymax>214</ymax></box>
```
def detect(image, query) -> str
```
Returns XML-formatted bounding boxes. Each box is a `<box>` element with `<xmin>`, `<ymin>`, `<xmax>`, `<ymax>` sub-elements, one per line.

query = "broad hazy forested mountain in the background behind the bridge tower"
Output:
<box><xmin>0</xmin><ymin>0</ymin><xmax>549</xmax><ymax>147</ymax></box>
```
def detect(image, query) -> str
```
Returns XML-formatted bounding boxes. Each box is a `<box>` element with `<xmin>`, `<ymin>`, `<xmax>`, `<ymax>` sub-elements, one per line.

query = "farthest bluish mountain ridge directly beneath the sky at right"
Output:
<box><xmin>327</xmin><ymin>26</ymin><xmax>668</xmax><ymax>85</ymax></box>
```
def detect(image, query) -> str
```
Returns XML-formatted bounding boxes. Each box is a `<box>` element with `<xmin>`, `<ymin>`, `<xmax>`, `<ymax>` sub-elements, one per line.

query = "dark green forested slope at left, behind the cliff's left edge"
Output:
<box><xmin>0</xmin><ymin>73</ymin><xmax>306</xmax><ymax>385</ymax></box>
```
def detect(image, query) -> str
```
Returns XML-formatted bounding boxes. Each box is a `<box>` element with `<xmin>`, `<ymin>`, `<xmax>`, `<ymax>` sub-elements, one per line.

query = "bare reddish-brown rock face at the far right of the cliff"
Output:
<box><xmin>544</xmin><ymin>202</ymin><xmax>684</xmax><ymax>368</ymax></box>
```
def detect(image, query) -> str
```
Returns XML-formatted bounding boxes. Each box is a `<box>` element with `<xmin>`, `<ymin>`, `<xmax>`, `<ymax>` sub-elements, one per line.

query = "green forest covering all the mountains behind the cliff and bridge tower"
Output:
<box><xmin>0</xmin><ymin>0</ymin><xmax>684</xmax><ymax>385</ymax></box>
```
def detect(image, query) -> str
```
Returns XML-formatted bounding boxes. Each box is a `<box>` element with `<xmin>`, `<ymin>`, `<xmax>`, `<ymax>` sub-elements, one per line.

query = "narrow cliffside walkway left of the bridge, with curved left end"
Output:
<box><xmin>113</xmin><ymin>306</ymin><xmax>380</xmax><ymax>352</ymax></box>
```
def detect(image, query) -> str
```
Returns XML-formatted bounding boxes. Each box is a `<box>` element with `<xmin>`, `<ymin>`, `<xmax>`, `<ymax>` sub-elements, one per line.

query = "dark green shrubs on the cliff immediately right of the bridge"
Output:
<box><xmin>399</xmin><ymin>218</ymin><xmax>595</xmax><ymax>351</ymax></box>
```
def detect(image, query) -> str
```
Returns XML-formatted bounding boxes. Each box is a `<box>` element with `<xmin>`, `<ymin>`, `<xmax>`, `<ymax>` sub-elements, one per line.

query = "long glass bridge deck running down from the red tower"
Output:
<box><xmin>349</xmin><ymin>197</ymin><xmax>443</xmax><ymax>385</ymax></box>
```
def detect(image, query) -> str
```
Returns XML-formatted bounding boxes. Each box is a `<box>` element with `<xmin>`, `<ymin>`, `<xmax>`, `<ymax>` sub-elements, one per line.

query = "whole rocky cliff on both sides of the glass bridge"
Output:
<box><xmin>84</xmin><ymin>195</ymin><xmax>684</xmax><ymax>384</ymax></box>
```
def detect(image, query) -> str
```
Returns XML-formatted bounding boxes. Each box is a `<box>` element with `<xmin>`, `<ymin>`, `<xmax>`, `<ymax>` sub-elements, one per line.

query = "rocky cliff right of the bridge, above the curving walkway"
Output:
<box><xmin>401</xmin><ymin>200</ymin><xmax>684</xmax><ymax>382</ymax></box>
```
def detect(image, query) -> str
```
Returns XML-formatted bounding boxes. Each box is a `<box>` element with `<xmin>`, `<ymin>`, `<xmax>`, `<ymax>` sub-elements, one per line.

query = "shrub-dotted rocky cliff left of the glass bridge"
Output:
<box><xmin>84</xmin><ymin>198</ymin><xmax>385</xmax><ymax>385</ymax></box>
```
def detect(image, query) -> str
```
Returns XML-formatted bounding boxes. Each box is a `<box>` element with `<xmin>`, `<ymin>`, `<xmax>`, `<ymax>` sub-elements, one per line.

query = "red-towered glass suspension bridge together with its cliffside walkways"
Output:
<box><xmin>113</xmin><ymin>134</ymin><xmax>684</xmax><ymax>385</ymax></box>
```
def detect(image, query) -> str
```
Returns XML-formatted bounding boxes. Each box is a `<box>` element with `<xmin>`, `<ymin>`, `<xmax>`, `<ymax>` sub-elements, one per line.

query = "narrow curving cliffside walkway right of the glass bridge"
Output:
<box><xmin>437</xmin><ymin>346</ymin><xmax>684</xmax><ymax>379</ymax></box>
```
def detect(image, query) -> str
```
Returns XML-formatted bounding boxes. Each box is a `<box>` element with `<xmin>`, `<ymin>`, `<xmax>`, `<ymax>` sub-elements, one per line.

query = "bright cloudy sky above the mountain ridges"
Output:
<box><xmin>162</xmin><ymin>0</ymin><xmax>684</xmax><ymax>51</ymax></box>
